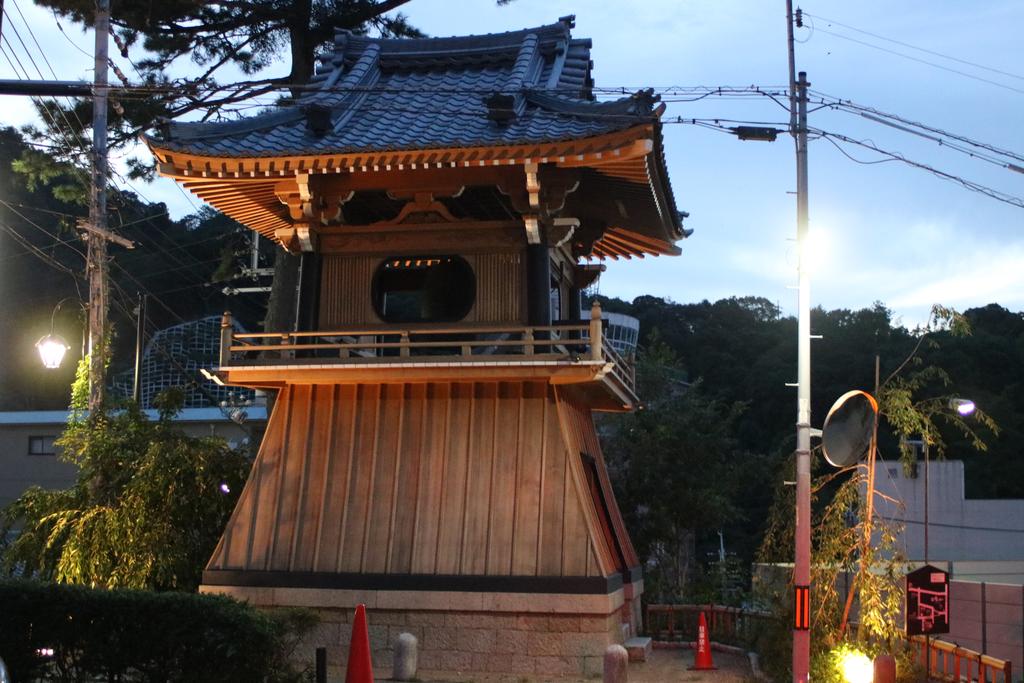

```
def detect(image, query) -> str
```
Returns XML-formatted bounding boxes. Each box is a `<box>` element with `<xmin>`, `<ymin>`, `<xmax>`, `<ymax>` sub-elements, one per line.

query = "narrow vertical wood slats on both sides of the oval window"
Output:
<box><xmin>318</xmin><ymin>250</ymin><xmax>526</xmax><ymax>330</ymax></box>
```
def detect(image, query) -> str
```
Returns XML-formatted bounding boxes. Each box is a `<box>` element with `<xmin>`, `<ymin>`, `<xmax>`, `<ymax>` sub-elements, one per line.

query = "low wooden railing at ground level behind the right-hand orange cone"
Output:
<box><xmin>646</xmin><ymin>604</ymin><xmax>774</xmax><ymax>645</ymax></box>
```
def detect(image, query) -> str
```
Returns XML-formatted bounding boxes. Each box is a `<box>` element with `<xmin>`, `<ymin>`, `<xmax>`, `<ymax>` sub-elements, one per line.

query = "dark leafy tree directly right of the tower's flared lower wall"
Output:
<box><xmin>602</xmin><ymin>339</ymin><xmax>756</xmax><ymax>601</ymax></box>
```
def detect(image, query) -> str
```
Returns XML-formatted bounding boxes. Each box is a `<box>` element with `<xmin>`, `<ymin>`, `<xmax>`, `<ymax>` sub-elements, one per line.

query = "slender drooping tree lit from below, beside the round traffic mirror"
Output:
<box><xmin>761</xmin><ymin>305</ymin><xmax>998</xmax><ymax>678</ymax></box>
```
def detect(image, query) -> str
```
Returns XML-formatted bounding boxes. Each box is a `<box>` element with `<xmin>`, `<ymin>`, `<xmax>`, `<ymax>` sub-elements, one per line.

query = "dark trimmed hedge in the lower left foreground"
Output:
<box><xmin>0</xmin><ymin>580</ymin><xmax>316</xmax><ymax>683</ymax></box>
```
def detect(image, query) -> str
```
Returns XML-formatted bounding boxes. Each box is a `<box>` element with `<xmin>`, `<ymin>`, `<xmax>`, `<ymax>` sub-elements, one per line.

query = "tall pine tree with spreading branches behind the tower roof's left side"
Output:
<box><xmin>20</xmin><ymin>0</ymin><xmax>420</xmax><ymax>330</ymax></box>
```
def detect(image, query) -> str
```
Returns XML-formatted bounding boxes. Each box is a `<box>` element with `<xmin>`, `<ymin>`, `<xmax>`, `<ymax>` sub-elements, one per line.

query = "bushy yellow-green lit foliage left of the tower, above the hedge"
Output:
<box><xmin>0</xmin><ymin>389</ymin><xmax>249</xmax><ymax>590</ymax></box>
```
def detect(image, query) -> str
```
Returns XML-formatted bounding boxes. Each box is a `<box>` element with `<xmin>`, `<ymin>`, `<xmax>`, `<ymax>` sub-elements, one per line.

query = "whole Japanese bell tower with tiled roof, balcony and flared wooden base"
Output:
<box><xmin>147</xmin><ymin>17</ymin><xmax>685</xmax><ymax>674</ymax></box>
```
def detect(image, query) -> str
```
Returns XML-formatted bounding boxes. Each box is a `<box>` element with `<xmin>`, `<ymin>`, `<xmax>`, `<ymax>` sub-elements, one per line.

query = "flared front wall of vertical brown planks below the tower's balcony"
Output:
<box><xmin>207</xmin><ymin>380</ymin><xmax>618</xmax><ymax>578</ymax></box>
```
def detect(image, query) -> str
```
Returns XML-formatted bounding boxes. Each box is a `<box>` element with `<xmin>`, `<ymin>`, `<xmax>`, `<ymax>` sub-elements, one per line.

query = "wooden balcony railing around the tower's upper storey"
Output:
<box><xmin>220</xmin><ymin>305</ymin><xmax>636</xmax><ymax>393</ymax></box>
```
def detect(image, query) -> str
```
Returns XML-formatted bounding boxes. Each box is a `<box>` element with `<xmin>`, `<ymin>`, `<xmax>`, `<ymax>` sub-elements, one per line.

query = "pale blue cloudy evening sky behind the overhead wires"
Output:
<box><xmin>0</xmin><ymin>0</ymin><xmax>1024</xmax><ymax>327</ymax></box>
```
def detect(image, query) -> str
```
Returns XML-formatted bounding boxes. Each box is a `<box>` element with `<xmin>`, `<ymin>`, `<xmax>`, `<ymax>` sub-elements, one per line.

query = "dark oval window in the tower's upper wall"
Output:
<box><xmin>373</xmin><ymin>256</ymin><xmax>476</xmax><ymax>323</ymax></box>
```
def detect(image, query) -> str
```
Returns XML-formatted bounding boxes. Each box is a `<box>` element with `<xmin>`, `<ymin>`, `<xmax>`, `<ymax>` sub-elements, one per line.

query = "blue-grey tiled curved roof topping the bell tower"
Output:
<box><xmin>150</xmin><ymin>17</ymin><xmax>654</xmax><ymax>158</ymax></box>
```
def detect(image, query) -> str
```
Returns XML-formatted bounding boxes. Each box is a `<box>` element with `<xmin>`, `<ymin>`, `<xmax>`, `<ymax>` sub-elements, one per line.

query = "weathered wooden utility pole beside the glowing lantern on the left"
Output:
<box><xmin>86</xmin><ymin>0</ymin><xmax>111</xmax><ymax>411</ymax></box>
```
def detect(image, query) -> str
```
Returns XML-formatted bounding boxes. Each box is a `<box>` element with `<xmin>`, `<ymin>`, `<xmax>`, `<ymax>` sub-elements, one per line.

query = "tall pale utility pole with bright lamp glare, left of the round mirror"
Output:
<box><xmin>785</xmin><ymin>0</ymin><xmax>811</xmax><ymax>683</ymax></box>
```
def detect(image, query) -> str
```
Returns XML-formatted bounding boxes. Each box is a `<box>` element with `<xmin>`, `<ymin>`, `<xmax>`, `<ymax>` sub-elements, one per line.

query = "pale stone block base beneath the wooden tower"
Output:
<box><xmin>201</xmin><ymin>586</ymin><xmax>633</xmax><ymax>681</ymax></box>
